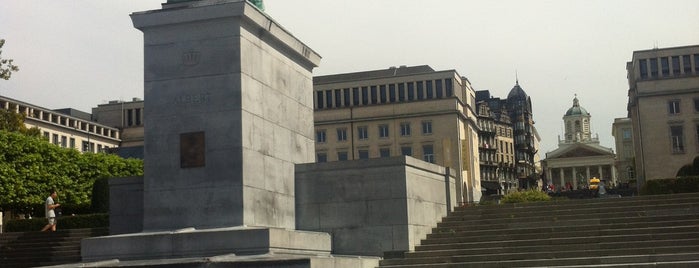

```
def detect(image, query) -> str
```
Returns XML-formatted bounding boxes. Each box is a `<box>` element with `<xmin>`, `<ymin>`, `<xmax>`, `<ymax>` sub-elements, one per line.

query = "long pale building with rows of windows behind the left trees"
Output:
<box><xmin>0</xmin><ymin>96</ymin><xmax>120</xmax><ymax>152</ymax></box>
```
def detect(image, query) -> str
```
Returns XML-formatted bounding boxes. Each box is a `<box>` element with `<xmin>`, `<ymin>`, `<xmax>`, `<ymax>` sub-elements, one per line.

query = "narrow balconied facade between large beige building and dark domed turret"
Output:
<box><xmin>476</xmin><ymin>90</ymin><xmax>519</xmax><ymax>194</ymax></box>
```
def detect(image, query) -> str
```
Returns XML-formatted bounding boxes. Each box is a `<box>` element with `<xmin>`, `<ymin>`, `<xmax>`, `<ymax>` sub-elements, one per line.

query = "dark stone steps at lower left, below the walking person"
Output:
<box><xmin>0</xmin><ymin>228</ymin><xmax>109</xmax><ymax>268</ymax></box>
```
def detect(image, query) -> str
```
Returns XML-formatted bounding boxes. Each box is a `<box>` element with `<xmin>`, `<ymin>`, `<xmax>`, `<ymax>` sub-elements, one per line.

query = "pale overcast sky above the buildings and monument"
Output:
<box><xmin>0</xmin><ymin>0</ymin><xmax>699</xmax><ymax>155</ymax></box>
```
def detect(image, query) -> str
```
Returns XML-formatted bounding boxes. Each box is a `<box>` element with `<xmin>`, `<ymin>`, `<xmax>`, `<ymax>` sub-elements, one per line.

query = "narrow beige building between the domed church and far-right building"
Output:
<box><xmin>612</xmin><ymin>118</ymin><xmax>636</xmax><ymax>183</ymax></box>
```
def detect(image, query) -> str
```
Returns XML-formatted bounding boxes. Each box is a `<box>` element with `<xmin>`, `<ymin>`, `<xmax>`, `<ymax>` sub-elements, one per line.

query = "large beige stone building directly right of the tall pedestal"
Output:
<box><xmin>313</xmin><ymin>65</ymin><xmax>481</xmax><ymax>202</ymax></box>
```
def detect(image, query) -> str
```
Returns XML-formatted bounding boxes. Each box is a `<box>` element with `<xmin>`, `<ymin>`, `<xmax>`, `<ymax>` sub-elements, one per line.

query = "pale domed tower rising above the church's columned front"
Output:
<box><xmin>563</xmin><ymin>96</ymin><xmax>592</xmax><ymax>143</ymax></box>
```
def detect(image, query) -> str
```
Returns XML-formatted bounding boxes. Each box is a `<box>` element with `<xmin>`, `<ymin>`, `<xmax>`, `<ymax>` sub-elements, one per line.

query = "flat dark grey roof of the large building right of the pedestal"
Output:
<box><xmin>313</xmin><ymin>65</ymin><xmax>435</xmax><ymax>85</ymax></box>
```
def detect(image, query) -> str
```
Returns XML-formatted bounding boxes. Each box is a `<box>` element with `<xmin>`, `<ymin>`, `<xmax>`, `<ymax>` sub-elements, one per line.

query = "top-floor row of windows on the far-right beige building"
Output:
<box><xmin>638</xmin><ymin>54</ymin><xmax>699</xmax><ymax>79</ymax></box>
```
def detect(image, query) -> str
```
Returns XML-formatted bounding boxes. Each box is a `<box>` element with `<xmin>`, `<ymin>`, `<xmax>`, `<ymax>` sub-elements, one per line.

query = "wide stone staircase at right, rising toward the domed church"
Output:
<box><xmin>380</xmin><ymin>193</ymin><xmax>699</xmax><ymax>268</ymax></box>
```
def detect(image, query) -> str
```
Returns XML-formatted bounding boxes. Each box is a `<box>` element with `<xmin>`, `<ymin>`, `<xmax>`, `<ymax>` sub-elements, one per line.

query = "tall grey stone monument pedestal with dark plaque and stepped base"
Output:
<box><xmin>74</xmin><ymin>0</ymin><xmax>378</xmax><ymax>267</ymax></box>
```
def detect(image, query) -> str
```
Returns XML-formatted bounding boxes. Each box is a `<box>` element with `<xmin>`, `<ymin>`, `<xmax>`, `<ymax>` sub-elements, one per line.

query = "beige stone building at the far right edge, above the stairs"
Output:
<box><xmin>626</xmin><ymin>45</ymin><xmax>699</xmax><ymax>185</ymax></box>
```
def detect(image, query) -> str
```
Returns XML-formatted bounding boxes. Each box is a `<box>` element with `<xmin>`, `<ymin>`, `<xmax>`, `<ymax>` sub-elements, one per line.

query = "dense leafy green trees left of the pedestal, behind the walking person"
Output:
<box><xmin>0</xmin><ymin>130</ymin><xmax>143</xmax><ymax>212</ymax></box>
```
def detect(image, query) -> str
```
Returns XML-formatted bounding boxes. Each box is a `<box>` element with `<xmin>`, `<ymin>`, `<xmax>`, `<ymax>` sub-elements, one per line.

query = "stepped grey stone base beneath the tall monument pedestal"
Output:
<box><xmin>69</xmin><ymin>227</ymin><xmax>380</xmax><ymax>268</ymax></box>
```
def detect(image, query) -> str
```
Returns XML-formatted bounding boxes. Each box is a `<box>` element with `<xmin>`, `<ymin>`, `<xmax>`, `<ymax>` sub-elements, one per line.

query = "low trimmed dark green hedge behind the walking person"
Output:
<box><xmin>4</xmin><ymin>214</ymin><xmax>109</xmax><ymax>232</ymax></box>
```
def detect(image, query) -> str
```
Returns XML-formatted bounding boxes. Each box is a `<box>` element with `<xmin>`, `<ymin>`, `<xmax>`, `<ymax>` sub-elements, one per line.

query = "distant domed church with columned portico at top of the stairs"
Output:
<box><xmin>543</xmin><ymin>95</ymin><xmax>617</xmax><ymax>190</ymax></box>
